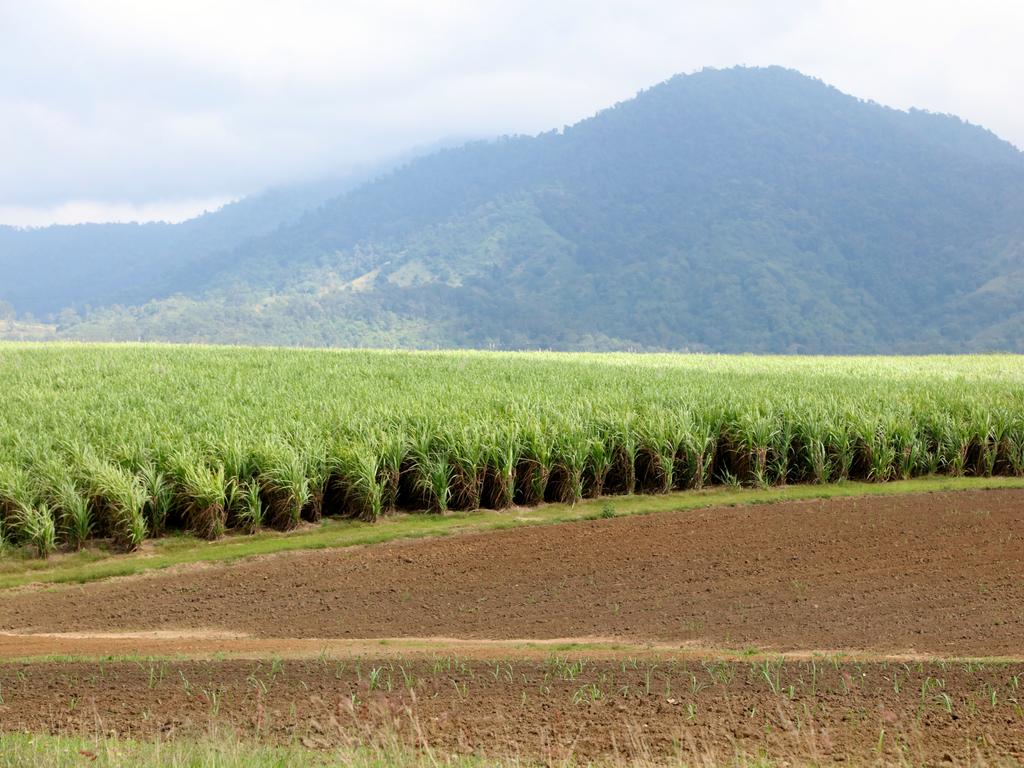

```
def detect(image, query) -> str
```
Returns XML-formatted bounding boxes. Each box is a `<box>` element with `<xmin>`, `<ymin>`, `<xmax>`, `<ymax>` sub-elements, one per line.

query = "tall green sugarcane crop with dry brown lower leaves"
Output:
<box><xmin>0</xmin><ymin>344</ymin><xmax>1024</xmax><ymax>556</ymax></box>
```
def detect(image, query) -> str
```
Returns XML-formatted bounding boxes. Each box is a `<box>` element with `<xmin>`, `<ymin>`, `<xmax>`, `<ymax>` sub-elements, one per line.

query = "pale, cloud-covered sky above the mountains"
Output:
<box><xmin>0</xmin><ymin>0</ymin><xmax>1024</xmax><ymax>226</ymax></box>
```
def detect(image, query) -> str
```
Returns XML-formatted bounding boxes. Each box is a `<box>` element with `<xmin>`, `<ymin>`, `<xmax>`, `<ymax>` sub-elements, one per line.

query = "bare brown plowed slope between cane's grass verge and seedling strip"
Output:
<box><xmin>0</xmin><ymin>490</ymin><xmax>1024</xmax><ymax>655</ymax></box>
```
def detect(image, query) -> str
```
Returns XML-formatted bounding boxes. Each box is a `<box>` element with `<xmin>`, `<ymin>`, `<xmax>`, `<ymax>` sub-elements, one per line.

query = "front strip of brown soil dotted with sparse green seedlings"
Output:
<box><xmin>0</xmin><ymin>655</ymin><xmax>1024</xmax><ymax>765</ymax></box>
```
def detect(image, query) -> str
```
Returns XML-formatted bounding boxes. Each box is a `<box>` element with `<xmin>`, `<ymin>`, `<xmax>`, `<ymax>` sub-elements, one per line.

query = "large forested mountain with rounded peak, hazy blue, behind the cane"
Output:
<box><xmin>6</xmin><ymin>68</ymin><xmax>1024</xmax><ymax>353</ymax></box>
